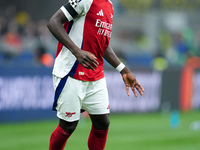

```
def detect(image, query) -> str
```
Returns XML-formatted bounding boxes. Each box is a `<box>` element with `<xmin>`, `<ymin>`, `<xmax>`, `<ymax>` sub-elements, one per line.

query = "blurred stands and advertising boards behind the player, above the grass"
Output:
<box><xmin>0</xmin><ymin>0</ymin><xmax>200</xmax><ymax>149</ymax></box>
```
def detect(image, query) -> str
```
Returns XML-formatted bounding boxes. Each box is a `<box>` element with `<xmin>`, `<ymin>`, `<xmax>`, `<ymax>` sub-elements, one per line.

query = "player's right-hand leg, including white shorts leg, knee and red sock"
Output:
<box><xmin>82</xmin><ymin>78</ymin><xmax>110</xmax><ymax>150</ymax></box>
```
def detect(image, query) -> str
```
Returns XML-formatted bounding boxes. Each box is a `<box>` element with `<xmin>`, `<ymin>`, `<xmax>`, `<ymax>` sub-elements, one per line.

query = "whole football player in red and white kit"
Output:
<box><xmin>48</xmin><ymin>0</ymin><xmax>144</xmax><ymax>150</ymax></box>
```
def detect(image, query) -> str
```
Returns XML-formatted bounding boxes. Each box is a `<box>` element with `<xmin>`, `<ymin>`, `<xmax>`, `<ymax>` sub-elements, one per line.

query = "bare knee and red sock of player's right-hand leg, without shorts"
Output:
<box><xmin>88</xmin><ymin>114</ymin><xmax>110</xmax><ymax>150</ymax></box>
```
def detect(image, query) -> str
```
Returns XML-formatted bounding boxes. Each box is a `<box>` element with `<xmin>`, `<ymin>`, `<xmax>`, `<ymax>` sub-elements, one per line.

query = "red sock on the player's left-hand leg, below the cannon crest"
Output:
<box><xmin>49</xmin><ymin>125</ymin><xmax>71</xmax><ymax>150</ymax></box>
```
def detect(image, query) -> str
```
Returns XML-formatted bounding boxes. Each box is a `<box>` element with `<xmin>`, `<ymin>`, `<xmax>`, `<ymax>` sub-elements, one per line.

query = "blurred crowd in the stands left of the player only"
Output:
<box><xmin>0</xmin><ymin>1</ymin><xmax>56</xmax><ymax>67</ymax></box>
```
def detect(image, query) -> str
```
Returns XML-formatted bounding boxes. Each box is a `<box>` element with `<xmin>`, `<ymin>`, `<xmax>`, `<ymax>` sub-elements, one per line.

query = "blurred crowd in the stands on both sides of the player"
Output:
<box><xmin>0</xmin><ymin>0</ymin><xmax>200</xmax><ymax>70</ymax></box>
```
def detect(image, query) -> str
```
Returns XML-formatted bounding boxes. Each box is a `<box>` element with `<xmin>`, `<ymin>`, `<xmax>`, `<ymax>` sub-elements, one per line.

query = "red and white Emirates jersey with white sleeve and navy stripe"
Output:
<box><xmin>53</xmin><ymin>0</ymin><xmax>114</xmax><ymax>81</ymax></box>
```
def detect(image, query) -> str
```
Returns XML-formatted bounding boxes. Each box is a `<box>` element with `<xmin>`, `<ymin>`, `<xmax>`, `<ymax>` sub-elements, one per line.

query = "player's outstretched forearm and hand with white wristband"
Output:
<box><xmin>103</xmin><ymin>46</ymin><xmax>144</xmax><ymax>97</ymax></box>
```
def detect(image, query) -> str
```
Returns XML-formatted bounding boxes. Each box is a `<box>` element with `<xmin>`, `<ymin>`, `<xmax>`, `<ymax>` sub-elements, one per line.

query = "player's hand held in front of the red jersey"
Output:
<box><xmin>76</xmin><ymin>50</ymin><xmax>99</xmax><ymax>71</ymax></box>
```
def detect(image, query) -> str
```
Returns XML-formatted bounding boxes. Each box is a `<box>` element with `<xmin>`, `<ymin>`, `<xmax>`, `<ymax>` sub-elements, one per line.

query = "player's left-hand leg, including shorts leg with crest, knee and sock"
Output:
<box><xmin>49</xmin><ymin>76</ymin><xmax>81</xmax><ymax>150</ymax></box>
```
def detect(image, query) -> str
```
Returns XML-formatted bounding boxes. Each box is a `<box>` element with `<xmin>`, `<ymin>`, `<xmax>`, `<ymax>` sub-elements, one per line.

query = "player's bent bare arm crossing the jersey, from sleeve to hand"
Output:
<box><xmin>47</xmin><ymin>4</ymin><xmax>98</xmax><ymax>70</ymax></box>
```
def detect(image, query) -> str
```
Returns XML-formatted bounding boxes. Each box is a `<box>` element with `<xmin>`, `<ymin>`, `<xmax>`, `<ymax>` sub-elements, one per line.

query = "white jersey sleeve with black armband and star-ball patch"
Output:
<box><xmin>60</xmin><ymin>0</ymin><xmax>93</xmax><ymax>21</ymax></box>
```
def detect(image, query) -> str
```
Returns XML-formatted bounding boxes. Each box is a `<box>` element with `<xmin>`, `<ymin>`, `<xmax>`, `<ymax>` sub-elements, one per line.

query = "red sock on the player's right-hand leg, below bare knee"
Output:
<box><xmin>88</xmin><ymin>126</ymin><xmax>108</xmax><ymax>150</ymax></box>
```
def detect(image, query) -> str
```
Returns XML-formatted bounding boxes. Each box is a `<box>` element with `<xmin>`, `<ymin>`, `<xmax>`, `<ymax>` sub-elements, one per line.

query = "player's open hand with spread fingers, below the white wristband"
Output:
<box><xmin>122</xmin><ymin>69</ymin><xmax>144</xmax><ymax>97</ymax></box>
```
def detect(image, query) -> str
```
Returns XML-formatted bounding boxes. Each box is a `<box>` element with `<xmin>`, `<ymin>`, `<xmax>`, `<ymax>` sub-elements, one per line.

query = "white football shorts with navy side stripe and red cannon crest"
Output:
<box><xmin>53</xmin><ymin>75</ymin><xmax>110</xmax><ymax>122</ymax></box>
